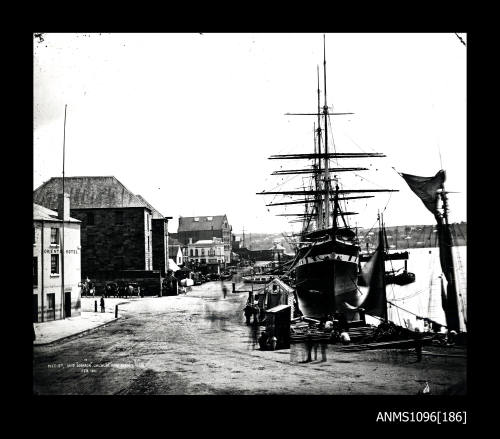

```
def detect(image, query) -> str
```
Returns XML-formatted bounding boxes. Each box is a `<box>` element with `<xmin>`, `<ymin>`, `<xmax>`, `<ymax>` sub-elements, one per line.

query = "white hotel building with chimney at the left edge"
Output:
<box><xmin>33</xmin><ymin>199</ymin><xmax>81</xmax><ymax>322</ymax></box>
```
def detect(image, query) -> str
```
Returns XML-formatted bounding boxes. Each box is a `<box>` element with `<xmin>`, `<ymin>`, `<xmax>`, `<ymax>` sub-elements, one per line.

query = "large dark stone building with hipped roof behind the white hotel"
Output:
<box><xmin>33</xmin><ymin>177</ymin><xmax>153</xmax><ymax>279</ymax></box>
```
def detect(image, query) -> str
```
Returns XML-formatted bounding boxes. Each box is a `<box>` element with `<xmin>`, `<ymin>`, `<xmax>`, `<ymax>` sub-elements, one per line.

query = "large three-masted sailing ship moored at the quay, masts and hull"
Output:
<box><xmin>258</xmin><ymin>37</ymin><xmax>396</xmax><ymax>320</ymax></box>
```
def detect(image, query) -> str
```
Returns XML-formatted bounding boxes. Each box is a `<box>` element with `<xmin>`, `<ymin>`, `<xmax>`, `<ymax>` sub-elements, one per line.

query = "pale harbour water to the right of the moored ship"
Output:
<box><xmin>360</xmin><ymin>246</ymin><xmax>467</xmax><ymax>330</ymax></box>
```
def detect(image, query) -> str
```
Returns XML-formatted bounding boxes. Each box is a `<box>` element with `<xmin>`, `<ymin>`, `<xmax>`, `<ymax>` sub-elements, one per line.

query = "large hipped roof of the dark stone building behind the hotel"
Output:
<box><xmin>33</xmin><ymin>177</ymin><xmax>149</xmax><ymax>209</ymax></box>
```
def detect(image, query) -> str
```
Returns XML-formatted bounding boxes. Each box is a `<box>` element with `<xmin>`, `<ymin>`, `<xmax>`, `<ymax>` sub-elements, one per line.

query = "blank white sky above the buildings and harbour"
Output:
<box><xmin>33</xmin><ymin>33</ymin><xmax>467</xmax><ymax>233</ymax></box>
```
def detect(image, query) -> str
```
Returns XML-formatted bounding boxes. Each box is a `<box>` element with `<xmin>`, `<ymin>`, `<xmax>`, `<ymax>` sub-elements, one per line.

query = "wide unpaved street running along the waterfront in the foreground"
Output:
<box><xmin>33</xmin><ymin>282</ymin><xmax>466</xmax><ymax>395</ymax></box>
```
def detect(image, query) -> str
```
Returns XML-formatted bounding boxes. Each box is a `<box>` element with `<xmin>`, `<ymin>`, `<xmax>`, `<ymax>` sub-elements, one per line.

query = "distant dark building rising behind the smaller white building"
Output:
<box><xmin>176</xmin><ymin>215</ymin><xmax>232</xmax><ymax>264</ymax></box>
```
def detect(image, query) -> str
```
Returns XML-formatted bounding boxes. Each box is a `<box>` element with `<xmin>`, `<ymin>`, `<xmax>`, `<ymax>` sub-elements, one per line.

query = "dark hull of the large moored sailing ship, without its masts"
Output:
<box><xmin>295</xmin><ymin>241</ymin><xmax>362</xmax><ymax>320</ymax></box>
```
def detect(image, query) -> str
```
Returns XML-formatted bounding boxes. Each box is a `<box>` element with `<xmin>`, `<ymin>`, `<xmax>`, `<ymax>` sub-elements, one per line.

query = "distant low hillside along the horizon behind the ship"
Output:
<box><xmin>235</xmin><ymin>222</ymin><xmax>467</xmax><ymax>253</ymax></box>
